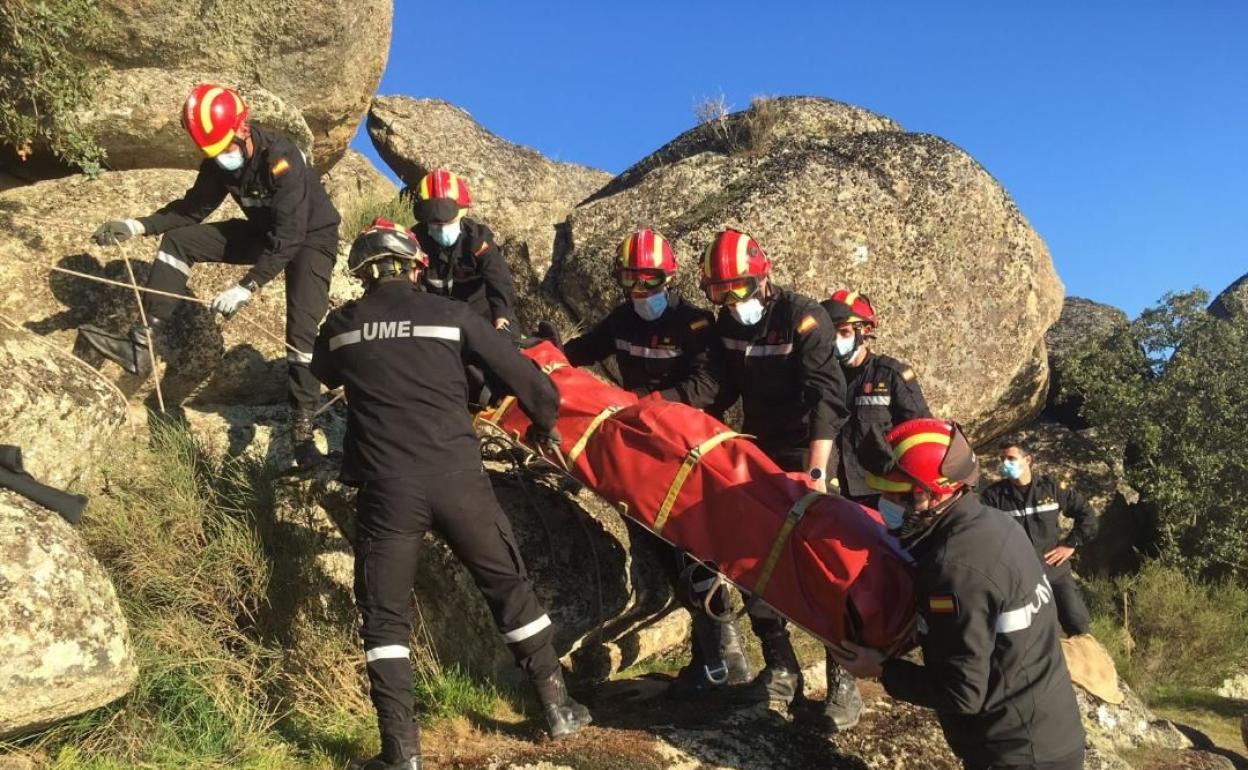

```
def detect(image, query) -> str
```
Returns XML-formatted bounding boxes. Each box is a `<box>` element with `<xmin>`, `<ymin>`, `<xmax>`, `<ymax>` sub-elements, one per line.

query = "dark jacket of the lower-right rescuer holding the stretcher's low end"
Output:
<box><xmin>880</xmin><ymin>493</ymin><xmax>1083</xmax><ymax>765</ymax></box>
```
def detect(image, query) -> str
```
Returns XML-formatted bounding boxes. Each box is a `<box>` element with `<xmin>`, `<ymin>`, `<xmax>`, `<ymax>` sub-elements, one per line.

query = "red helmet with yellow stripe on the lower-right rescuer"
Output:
<box><xmin>866</xmin><ymin>417</ymin><xmax>980</xmax><ymax>494</ymax></box>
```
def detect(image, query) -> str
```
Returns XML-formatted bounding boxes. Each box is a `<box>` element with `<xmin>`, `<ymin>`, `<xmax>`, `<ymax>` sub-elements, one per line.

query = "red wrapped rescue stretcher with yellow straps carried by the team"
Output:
<box><xmin>478</xmin><ymin>342</ymin><xmax>915</xmax><ymax>650</ymax></box>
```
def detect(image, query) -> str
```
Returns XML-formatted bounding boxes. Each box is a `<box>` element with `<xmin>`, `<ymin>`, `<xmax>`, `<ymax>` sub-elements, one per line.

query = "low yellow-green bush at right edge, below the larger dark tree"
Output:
<box><xmin>1086</xmin><ymin>560</ymin><xmax>1248</xmax><ymax>696</ymax></box>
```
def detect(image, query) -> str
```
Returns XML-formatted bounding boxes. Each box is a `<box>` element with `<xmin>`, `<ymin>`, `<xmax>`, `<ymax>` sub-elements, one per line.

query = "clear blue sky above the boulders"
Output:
<box><xmin>354</xmin><ymin>0</ymin><xmax>1248</xmax><ymax>314</ymax></box>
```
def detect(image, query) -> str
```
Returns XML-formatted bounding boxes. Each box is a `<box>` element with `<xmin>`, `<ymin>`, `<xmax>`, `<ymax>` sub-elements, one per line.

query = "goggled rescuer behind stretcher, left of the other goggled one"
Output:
<box><xmin>563</xmin><ymin>230</ymin><xmax>753</xmax><ymax>698</ymax></box>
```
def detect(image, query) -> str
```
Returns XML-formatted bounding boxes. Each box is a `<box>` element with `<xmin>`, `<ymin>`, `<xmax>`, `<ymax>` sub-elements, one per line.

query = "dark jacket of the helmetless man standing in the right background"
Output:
<box><xmin>981</xmin><ymin>474</ymin><xmax>1096</xmax><ymax>578</ymax></box>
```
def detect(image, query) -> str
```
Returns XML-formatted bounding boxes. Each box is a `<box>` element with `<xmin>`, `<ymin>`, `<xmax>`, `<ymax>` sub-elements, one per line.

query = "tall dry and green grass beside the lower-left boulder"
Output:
<box><xmin>0</xmin><ymin>426</ymin><xmax>504</xmax><ymax>770</ymax></box>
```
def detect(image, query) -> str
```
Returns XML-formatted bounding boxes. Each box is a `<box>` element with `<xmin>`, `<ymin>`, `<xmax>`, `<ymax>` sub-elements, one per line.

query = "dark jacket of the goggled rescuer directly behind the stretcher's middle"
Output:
<box><xmin>563</xmin><ymin>296</ymin><xmax>719</xmax><ymax>408</ymax></box>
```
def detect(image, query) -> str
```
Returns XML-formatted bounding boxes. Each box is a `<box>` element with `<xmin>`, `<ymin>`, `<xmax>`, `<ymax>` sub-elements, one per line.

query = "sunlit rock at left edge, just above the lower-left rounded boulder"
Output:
<box><xmin>0</xmin><ymin>317</ymin><xmax>126</xmax><ymax>488</ymax></box>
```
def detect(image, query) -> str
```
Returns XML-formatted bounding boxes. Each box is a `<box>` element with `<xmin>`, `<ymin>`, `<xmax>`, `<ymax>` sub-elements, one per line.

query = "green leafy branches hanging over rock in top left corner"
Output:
<box><xmin>0</xmin><ymin>0</ymin><xmax>104</xmax><ymax>173</ymax></box>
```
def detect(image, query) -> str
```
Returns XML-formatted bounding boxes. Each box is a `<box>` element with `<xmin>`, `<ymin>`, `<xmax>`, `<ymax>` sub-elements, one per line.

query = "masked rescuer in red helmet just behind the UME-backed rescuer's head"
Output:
<box><xmin>412</xmin><ymin>168</ymin><xmax>515</xmax><ymax>331</ymax></box>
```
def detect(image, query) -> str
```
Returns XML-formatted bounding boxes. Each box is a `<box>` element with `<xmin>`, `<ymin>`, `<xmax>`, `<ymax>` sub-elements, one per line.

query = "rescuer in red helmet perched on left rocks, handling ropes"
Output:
<box><xmin>79</xmin><ymin>84</ymin><xmax>338</xmax><ymax>465</ymax></box>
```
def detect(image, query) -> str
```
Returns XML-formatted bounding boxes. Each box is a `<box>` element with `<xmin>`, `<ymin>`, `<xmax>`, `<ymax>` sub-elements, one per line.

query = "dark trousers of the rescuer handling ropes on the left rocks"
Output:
<box><xmin>146</xmin><ymin>220</ymin><xmax>338</xmax><ymax>409</ymax></box>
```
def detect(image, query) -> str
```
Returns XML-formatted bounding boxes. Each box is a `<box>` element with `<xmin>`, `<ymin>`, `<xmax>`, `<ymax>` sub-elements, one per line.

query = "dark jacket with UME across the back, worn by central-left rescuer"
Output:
<box><xmin>311</xmin><ymin>280</ymin><xmax>559</xmax><ymax>483</ymax></box>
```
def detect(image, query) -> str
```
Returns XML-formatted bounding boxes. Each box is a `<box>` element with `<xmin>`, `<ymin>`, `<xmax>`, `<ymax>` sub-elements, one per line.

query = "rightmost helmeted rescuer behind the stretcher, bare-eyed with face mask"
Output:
<box><xmin>820</xmin><ymin>288</ymin><xmax>931</xmax><ymax>521</ymax></box>
